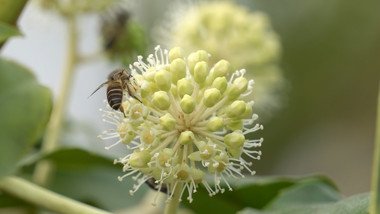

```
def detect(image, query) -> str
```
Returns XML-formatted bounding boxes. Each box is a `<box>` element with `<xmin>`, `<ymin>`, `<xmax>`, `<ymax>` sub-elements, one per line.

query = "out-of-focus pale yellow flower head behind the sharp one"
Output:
<box><xmin>157</xmin><ymin>1</ymin><xmax>285</xmax><ymax>118</ymax></box>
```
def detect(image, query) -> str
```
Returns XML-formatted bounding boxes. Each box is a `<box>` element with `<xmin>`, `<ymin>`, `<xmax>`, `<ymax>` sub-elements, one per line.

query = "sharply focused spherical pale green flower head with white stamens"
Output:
<box><xmin>99</xmin><ymin>46</ymin><xmax>263</xmax><ymax>202</ymax></box>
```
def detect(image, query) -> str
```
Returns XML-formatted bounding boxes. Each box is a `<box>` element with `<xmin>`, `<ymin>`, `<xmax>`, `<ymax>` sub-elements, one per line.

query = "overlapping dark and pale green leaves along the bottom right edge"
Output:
<box><xmin>185</xmin><ymin>176</ymin><xmax>368</xmax><ymax>214</ymax></box>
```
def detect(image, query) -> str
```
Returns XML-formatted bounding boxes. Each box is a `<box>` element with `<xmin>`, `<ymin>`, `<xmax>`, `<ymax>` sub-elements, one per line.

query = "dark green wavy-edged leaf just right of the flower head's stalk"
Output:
<box><xmin>183</xmin><ymin>176</ymin><xmax>335</xmax><ymax>214</ymax></box>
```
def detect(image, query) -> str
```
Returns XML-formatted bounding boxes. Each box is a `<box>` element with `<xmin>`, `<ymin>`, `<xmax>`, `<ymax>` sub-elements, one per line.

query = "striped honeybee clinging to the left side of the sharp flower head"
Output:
<box><xmin>90</xmin><ymin>68</ymin><xmax>142</xmax><ymax>117</ymax></box>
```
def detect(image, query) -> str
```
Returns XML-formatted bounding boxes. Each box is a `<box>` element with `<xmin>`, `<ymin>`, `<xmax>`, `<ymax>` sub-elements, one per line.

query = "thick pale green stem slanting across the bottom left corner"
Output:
<box><xmin>0</xmin><ymin>176</ymin><xmax>110</xmax><ymax>214</ymax></box>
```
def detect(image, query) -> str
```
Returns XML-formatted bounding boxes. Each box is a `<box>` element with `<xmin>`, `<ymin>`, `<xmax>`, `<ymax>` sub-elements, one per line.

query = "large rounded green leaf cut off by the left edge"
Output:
<box><xmin>0</xmin><ymin>58</ymin><xmax>52</xmax><ymax>177</ymax></box>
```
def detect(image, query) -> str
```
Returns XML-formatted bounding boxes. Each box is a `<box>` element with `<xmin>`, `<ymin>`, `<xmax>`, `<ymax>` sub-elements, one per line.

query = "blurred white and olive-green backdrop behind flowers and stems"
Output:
<box><xmin>1</xmin><ymin>0</ymin><xmax>380</xmax><ymax>199</ymax></box>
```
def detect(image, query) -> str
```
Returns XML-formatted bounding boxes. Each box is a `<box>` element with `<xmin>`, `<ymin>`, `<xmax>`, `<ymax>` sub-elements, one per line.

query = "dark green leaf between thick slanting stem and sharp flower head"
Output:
<box><xmin>24</xmin><ymin>148</ymin><xmax>148</xmax><ymax>210</ymax></box>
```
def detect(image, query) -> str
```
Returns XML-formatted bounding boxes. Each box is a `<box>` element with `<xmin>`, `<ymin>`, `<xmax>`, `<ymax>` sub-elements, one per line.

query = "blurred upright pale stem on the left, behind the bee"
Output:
<box><xmin>33</xmin><ymin>11</ymin><xmax>78</xmax><ymax>185</ymax></box>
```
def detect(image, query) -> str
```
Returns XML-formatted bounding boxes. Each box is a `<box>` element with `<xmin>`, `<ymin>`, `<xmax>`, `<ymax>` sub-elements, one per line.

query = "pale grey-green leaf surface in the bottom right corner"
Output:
<box><xmin>238</xmin><ymin>192</ymin><xmax>369</xmax><ymax>214</ymax></box>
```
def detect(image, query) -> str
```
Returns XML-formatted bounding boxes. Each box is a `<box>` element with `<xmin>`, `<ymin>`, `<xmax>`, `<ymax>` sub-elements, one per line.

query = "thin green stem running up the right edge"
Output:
<box><xmin>370</xmin><ymin>84</ymin><xmax>380</xmax><ymax>214</ymax></box>
